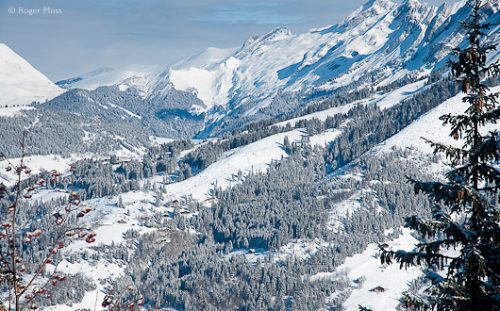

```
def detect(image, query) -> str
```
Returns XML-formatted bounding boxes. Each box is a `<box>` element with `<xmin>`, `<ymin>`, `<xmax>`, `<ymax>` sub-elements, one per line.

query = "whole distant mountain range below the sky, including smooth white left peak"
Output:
<box><xmin>0</xmin><ymin>0</ymin><xmax>500</xmax><ymax>147</ymax></box>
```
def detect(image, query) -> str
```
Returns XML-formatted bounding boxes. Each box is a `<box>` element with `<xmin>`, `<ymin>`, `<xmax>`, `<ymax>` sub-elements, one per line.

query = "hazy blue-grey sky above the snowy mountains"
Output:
<box><xmin>0</xmin><ymin>0</ymin><xmax>454</xmax><ymax>81</ymax></box>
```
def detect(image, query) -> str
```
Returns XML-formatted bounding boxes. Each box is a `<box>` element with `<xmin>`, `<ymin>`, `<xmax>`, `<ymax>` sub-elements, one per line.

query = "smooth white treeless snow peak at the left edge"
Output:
<box><xmin>0</xmin><ymin>43</ymin><xmax>64</xmax><ymax>109</ymax></box>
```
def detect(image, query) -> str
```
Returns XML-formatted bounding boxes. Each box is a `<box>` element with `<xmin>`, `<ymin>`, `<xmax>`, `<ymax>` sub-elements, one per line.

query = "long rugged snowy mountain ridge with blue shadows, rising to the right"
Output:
<box><xmin>59</xmin><ymin>0</ymin><xmax>500</xmax><ymax>132</ymax></box>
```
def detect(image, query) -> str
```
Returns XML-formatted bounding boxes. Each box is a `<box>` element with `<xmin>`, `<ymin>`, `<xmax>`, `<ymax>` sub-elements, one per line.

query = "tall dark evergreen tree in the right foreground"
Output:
<box><xmin>381</xmin><ymin>1</ymin><xmax>500</xmax><ymax>310</ymax></box>
